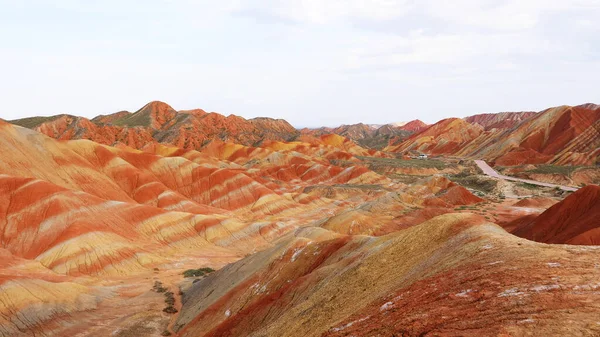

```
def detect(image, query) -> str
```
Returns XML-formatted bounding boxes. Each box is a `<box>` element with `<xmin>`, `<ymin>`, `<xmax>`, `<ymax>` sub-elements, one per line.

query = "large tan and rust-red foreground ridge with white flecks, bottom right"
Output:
<box><xmin>177</xmin><ymin>214</ymin><xmax>600</xmax><ymax>336</ymax></box>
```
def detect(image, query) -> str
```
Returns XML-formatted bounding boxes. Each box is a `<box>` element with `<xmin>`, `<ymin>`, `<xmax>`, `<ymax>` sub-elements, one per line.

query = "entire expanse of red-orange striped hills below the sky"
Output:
<box><xmin>0</xmin><ymin>102</ymin><xmax>600</xmax><ymax>337</ymax></box>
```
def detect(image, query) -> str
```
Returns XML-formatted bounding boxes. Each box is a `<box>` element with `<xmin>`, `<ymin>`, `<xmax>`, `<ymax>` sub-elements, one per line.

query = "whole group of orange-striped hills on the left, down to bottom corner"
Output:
<box><xmin>0</xmin><ymin>122</ymin><xmax>390</xmax><ymax>336</ymax></box>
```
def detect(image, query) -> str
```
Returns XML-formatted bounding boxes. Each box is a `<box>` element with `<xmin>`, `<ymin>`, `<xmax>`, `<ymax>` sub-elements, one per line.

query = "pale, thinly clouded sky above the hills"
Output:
<box><xmin>0</xmin><ymin>0</ymin><xmax>600</xmax><ymax>127</ymax></box>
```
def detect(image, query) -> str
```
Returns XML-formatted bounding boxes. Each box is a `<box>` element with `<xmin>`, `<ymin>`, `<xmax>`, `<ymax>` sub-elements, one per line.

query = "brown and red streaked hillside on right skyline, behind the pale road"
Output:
<box><xmin>385</xmin><ymin>104</ymin><xmax>600</xmax><ymax>166</ymax></box>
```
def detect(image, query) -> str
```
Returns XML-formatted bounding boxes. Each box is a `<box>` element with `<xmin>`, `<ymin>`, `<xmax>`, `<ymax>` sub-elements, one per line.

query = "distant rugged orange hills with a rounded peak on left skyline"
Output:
<box><xmin>11</xmin><ymin>101</ymin><xmax>299</xmax><ymax>149</ymax></box>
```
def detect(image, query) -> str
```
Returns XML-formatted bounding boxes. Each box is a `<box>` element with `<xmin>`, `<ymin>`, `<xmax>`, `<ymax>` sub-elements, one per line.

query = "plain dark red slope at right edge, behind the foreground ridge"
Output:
<box><xmin>512</xmin><ymin>185</ymin><xmax>600</xmax><ymax>245</ymax></box>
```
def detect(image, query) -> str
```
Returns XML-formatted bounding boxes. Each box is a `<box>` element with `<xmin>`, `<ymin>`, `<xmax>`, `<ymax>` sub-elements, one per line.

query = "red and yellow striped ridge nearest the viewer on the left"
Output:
<box><xmin>0</xmin><ymin>176</ymin><xmax>268</xmax><ymax>276</ymax></box>
